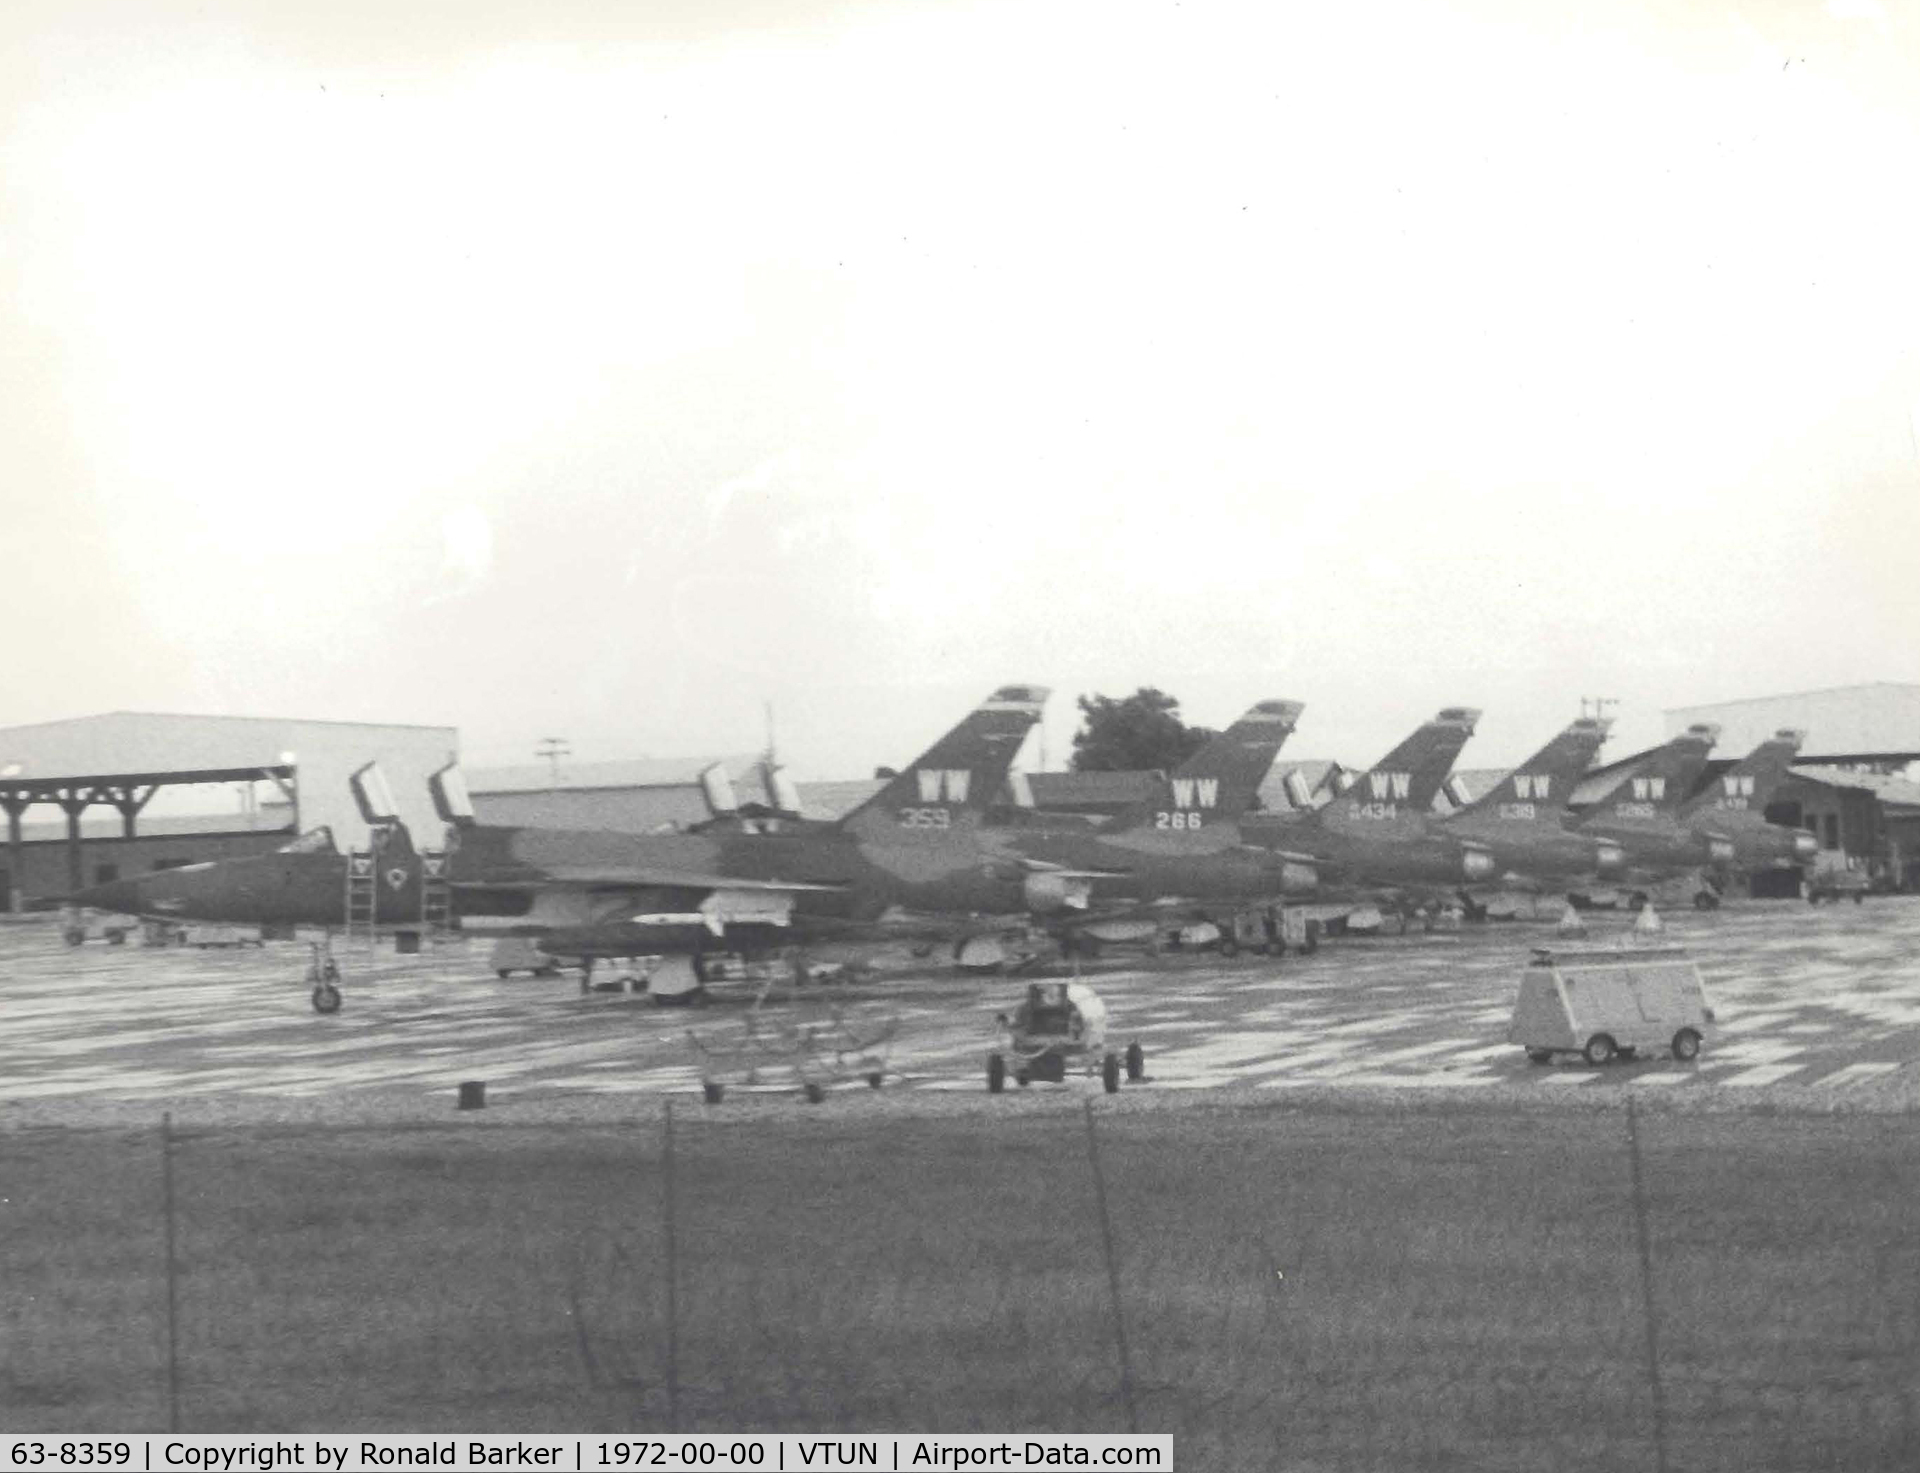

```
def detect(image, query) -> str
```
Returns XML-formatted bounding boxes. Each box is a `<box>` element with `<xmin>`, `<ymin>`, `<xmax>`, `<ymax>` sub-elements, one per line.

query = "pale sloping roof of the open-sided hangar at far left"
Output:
<box><xmin>0</xmin><ymin>711</ymin><xmax>457</xmax><ymax>784</ymax></box>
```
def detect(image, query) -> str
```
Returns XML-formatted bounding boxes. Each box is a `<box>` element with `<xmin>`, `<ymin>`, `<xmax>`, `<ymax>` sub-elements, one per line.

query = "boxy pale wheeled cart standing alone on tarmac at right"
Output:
<box><xmin>1507</xmin><ymin>947</ymin><xmax>1715</xmax><ymax>1066</ymax></box>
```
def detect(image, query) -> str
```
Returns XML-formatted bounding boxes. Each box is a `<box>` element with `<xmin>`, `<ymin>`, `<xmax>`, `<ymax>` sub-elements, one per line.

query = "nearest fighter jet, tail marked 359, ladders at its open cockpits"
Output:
<box><xmin>75</xmin><ymin>686</ymin><xmax>1046</xmax><ymax>1012</ymax></box>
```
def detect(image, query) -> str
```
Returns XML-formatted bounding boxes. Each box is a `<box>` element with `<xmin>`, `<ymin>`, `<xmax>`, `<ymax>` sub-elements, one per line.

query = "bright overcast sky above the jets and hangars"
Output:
<box><xmin>0</xmin><ymin>0</ymin><xmax>1920</xmax><ymax>778</ymax></box>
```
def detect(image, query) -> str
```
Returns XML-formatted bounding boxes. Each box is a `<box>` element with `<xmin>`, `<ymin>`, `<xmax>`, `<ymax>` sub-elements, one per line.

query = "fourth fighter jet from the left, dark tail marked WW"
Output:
<box><xmin>1438</xmin><ymin>716</ymin><xmax>1626</xmax><ymax>883</ymax></box>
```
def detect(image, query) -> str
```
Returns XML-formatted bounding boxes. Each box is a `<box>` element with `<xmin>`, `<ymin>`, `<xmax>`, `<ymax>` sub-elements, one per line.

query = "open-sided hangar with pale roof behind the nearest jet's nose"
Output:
<box><xmin>0</xmin><ymin>711</ymin><xmax>459</xmax><ymax>908</ymax></box>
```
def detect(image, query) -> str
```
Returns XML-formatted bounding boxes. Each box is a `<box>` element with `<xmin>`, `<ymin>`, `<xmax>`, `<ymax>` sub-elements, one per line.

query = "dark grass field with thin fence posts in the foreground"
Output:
<box><xmin>0</xmin><ymin>1095</ymin><xmax>1920</xmax><ymax>1469</ymax></box>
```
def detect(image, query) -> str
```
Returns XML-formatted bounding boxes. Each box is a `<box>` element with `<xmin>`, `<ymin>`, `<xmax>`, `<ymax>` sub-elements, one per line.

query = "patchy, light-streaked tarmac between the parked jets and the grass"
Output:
<box><xmin>0</xmin><ymin>897</ymin><xmax>1920</xmax><ymax>1123</ymax></box>
